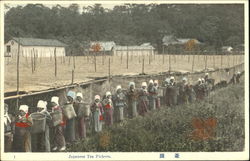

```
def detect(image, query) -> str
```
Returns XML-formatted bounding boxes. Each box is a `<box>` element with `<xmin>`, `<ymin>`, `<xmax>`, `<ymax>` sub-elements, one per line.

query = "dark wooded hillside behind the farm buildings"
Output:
<box><xmin>5</xmin><ymin>4</ymin><xmax>244</xmax><ymax>54</ymax></box>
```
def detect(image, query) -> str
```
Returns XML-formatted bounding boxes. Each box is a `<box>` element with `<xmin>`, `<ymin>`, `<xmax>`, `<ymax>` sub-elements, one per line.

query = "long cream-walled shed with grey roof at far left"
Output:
<box><xmin>4</xmin><ymin>37</ymin><xmax>67</xmax><ymax>57</ymax></box>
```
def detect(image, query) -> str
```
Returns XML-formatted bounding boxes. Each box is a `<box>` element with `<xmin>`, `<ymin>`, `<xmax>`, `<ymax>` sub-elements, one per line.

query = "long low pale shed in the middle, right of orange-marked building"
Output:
<box><xmin>115</xmin><ymin>43</ymin><xmax>155</xmax><ymax>56</ymax></box>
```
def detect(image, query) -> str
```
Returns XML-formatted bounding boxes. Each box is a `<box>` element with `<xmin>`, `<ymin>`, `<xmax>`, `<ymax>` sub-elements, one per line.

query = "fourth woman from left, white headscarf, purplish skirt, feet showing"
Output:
<box><xmin>51</xmin><ymin>96</ymin><xmax>66</xmax><ymax>151</ymax></box>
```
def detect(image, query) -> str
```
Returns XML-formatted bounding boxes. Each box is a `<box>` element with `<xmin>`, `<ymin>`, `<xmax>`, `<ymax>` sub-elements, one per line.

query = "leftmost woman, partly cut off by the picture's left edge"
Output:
<box><xmin>3</xmin><ymin>103</ymin><xmax>15</xmax><ymax>152</ymax></box>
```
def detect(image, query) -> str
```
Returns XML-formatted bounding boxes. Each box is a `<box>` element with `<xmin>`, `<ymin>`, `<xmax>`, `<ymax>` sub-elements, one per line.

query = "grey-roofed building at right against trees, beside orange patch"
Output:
<box><xmin>162</xmin><ymin>35</ymin><xmax>202</xmax><ymax>54</ymax></box>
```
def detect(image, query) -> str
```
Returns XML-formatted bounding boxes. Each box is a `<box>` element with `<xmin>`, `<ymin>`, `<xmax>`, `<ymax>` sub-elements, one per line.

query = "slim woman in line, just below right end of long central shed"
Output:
<box><xmin>148</xmin><ymin>79</ymin><xmax>157</xmax><ymax>110</ymax></box>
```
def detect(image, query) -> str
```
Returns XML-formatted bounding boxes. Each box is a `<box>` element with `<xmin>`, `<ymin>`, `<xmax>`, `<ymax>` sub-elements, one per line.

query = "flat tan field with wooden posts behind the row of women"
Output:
<box><xmin>4</xmin><ymin>55</ymin><xmax>244</xmax><ymax>92</ymax></box>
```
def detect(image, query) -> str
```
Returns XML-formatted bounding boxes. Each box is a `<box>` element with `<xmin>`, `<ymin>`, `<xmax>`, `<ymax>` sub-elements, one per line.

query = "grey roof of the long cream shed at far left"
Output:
<box><xmin>12</xmin><ymin>37</ymin><xmax>67</xmax><ymax>47</ymax></box>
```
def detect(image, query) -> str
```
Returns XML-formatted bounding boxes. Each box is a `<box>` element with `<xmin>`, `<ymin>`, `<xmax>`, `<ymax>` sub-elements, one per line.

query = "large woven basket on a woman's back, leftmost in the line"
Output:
<box><xmin>30</xmin><ymin>112</ymin><xmax>46</xmax><ymax>133</ymax></box>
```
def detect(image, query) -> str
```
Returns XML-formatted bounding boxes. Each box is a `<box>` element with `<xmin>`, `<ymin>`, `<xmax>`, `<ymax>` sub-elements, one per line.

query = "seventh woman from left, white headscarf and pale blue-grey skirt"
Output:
<box><xmin>90</xmin><ymin>95</ymin><xmax>104</xmax><ymax>133</ymax></box>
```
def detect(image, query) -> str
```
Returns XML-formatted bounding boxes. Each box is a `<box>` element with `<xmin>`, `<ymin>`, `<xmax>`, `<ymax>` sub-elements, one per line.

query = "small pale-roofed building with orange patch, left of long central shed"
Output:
<box><xmin>89</xmin><ymin>41</ymin><xmax>116</xmax><ymax>55</ymax></box>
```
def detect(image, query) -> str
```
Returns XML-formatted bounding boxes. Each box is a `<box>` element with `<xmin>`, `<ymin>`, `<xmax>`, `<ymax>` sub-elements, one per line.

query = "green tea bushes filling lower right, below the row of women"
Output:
<box><xmin>69</xmin><ymin>82</ymin><xmax>245</xmax><ymax>152</ymax></box>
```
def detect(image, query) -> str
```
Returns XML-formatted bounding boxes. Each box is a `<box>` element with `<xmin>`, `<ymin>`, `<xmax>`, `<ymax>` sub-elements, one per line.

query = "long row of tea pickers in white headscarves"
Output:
<box><xmin>4</xmin><ymin>72</ymin><xmax>240</xmax><ymax>152</ymax></box>
